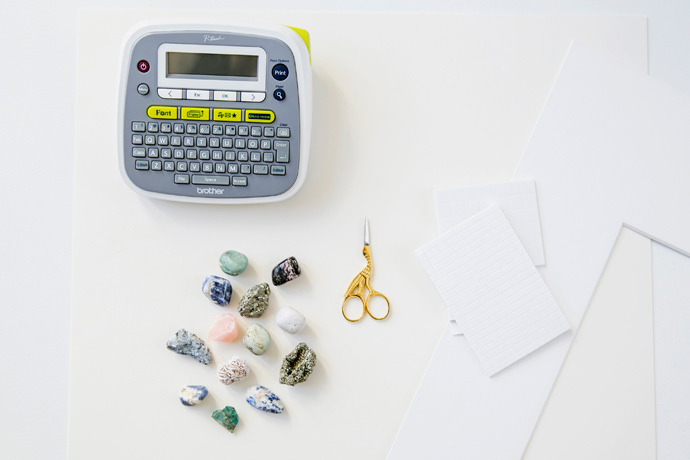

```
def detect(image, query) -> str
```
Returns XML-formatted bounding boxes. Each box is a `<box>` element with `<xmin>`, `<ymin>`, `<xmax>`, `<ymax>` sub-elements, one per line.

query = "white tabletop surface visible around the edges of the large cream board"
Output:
<box><xmin>0</xmin><ymin>0</ymin><xmax>690</xmax><ymax>459</ymax></box>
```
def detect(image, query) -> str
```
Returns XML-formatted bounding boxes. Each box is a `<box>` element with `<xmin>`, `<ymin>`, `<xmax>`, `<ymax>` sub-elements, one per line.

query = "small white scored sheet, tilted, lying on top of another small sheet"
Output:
<box><xmin>416</xmin><ymin>205</ymin><xmax>570</xmax><ymax>376</ymax></box>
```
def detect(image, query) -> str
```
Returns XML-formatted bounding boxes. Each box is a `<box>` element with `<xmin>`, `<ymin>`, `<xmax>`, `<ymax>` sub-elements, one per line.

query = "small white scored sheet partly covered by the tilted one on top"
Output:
<box><xmin>434</xmin><ymin>180</ymin><xmax>544</xmax><ymax>265</ymax></box>
